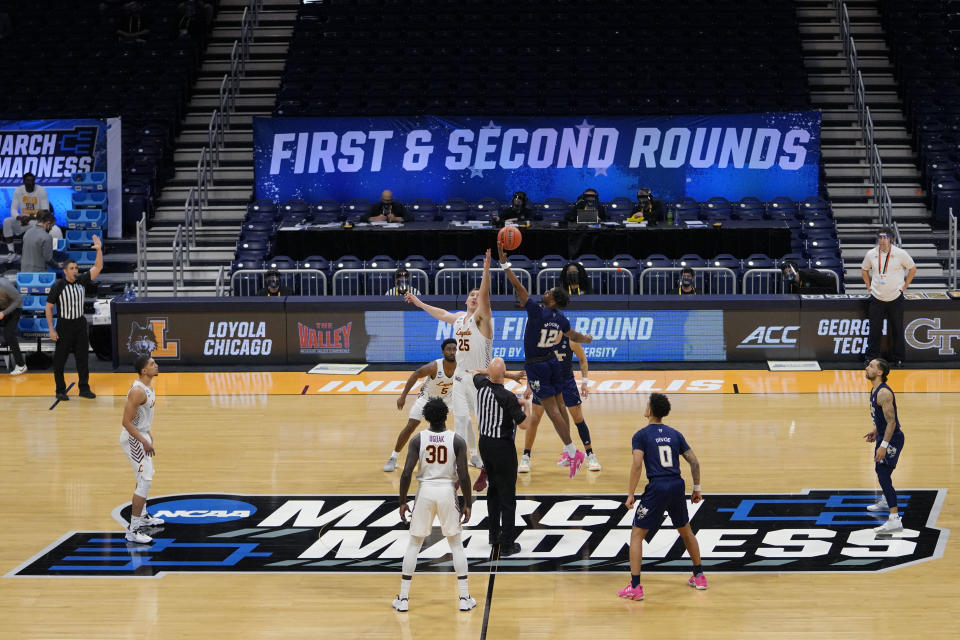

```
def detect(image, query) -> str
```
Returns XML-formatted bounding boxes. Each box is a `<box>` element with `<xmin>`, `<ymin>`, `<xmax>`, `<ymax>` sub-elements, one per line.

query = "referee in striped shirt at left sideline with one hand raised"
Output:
<box><xmin>46</xmin><ymin>236</ymin><xmax>103</xmax><ymax>400</ymax></box>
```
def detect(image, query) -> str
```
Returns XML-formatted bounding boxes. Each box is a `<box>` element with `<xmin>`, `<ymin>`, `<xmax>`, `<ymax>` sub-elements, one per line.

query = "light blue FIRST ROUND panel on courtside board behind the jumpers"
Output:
<box><xmin>364</xmin><ymin>310</ymin><xmax>726</xmax><ymax>362</ymax></box>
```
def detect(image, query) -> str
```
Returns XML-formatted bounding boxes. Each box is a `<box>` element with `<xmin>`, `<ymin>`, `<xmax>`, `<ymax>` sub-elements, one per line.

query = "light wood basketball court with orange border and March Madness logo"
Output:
<box><xmin>0</xmin><ymin>364</ymin><xmax>960</xmax><ymax>638</ymax></box>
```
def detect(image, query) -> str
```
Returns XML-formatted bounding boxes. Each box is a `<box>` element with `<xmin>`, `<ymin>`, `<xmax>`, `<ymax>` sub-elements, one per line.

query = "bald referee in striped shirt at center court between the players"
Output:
<box><xmin>473</xmin><ymin>358</ymin><xmax>529</xmax><ymax>556</ymax></box>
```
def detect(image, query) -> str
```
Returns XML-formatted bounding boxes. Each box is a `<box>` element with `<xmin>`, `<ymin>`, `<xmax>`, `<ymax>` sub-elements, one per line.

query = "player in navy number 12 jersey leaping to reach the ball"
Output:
<box><xmin>497</xmin><ymin>243</ymin><xmax>593</xmax><ymax>478</ymax></box>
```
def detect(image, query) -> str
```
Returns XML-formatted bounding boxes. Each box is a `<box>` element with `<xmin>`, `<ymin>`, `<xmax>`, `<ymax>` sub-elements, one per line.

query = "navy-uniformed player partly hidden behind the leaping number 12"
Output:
<box><xmin>517</xmin><ymin>336</ymin><xmax>603</xmax><ymax>473</ymax></box>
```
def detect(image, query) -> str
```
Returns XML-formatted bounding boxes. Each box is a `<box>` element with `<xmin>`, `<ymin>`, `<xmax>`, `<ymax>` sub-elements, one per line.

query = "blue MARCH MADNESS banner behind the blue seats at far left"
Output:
<box><xmin>0</xmin><ymin>119</ymin><xmax>109</xmax><ymax>226</ymax></box>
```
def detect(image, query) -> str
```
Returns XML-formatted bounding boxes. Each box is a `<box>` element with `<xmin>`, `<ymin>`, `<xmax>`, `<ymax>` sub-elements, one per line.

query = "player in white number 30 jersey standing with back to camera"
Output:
<box><xmin>393</xmin><ymin>398</ymin><xmax>477</xmax><ymax>611</ymax></box>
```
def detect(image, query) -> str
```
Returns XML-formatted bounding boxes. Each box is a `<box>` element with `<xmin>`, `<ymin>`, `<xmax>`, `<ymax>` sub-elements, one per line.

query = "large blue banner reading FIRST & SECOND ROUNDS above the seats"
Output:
<box><xmin>253</xmin><ymin>111</ymin><xmax>820</xmax><ymax>202</ymax></box>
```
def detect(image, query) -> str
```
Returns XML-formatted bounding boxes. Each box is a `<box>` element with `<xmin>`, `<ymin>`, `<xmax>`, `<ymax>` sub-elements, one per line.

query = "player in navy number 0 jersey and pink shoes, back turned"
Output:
<box><xmin>617</xmin><ymin>393</ymin><xmax>707</xmax><ymax>600</ymax></box>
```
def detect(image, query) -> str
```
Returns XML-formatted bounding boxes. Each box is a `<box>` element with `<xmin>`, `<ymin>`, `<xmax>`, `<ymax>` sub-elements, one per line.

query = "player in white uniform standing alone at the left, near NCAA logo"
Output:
<box><xmin>120</xmin><ymin>355</ymin><xmax>163</xmax><ymax>544</ymax></box>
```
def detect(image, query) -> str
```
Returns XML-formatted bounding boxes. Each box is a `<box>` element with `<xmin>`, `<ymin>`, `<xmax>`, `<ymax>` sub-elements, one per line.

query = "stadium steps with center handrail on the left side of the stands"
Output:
<box><xmin>147</xmin><ymin>0</ymin><xmax>299</xmax><ymax>296</ymax></box>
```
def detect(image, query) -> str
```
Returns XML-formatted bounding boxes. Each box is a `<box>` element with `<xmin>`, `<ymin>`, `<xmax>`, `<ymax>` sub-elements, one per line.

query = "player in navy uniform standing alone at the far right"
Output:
<box><xmin>863</xmin><ymin>358</ymin><xmax>904</xmax><ymax>534</ymax></box>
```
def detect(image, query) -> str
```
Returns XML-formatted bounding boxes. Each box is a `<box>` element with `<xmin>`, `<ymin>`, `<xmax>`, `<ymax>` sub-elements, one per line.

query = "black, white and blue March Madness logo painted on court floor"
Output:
<box><xmin>8</xmin><ymin>489</ymin><xmax>949</xmax><ymax>576</ymax></box>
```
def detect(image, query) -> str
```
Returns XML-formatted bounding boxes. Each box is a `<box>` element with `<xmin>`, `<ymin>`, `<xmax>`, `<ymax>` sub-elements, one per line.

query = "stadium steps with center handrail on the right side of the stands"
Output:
<box><xmin>796</xmin><ymin>0</ymin><xmax>945</xmax><ymax>292</ymax></box>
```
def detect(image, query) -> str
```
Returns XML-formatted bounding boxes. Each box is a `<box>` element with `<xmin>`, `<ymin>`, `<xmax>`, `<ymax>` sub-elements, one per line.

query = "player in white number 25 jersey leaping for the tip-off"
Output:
<box><xmin>406</xmin><ymin>249</ymin><xmax>522</xmax><ymax>467</ymax></box>
